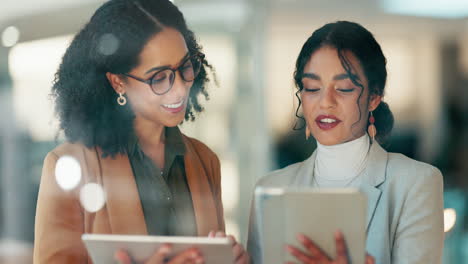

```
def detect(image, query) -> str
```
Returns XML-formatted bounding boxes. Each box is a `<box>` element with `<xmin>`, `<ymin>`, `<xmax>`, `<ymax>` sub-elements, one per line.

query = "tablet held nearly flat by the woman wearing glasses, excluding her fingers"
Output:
<box><xmin>81</xmin><ymin>234</ymin><xmax>234</xmax><ymax>264</ymax></box>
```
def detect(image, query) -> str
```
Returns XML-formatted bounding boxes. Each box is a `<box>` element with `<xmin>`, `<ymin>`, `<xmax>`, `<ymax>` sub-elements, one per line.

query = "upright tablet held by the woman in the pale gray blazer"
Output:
<box><xmin>255</xmin><ymin>187</ymin><xmax>367</xmax><ymax>263</ymax></box>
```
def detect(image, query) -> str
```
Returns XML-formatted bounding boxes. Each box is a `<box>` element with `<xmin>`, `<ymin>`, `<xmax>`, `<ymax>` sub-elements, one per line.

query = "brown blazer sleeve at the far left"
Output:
<box><xmin>33</xmin><ymin>152</ymin><xmax>88</xmax><ymax>264</ymax></box>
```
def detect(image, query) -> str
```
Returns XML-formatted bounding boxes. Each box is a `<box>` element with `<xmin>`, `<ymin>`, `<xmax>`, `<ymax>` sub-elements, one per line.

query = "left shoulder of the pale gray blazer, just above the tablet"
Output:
<box><xmin>257</xmin><ymin>161</ymin><xmax>305</xmax><ymax>187</ymax></box>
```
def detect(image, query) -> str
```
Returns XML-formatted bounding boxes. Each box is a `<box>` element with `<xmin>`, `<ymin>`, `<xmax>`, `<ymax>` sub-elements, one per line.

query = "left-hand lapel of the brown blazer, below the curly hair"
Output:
<box><xmin>98</xmin><ymin>153</ymin><xmax>148</xmax><ymax>235</ymax></box>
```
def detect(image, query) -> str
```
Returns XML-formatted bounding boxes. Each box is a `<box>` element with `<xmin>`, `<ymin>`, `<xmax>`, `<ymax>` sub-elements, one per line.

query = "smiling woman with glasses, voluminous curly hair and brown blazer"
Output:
<box><xmin>34</xmin><ymin>0</ymin><xmax>248</xmax><ymax>263</ymax></box>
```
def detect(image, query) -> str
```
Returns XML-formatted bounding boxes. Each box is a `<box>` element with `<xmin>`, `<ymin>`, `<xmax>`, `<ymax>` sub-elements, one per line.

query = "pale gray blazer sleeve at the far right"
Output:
<box><xmin>392</xmin><ymin>166</ymin><xmax>444</xmax><ymax>263</ymax></box>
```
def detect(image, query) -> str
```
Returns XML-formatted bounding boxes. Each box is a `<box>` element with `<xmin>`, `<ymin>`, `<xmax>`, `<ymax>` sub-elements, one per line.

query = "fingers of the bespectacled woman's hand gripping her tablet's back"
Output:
<box><xmin>114</xmin><ymin>244</ymin><xmax>205</xmax><ymax>264</ymax></box>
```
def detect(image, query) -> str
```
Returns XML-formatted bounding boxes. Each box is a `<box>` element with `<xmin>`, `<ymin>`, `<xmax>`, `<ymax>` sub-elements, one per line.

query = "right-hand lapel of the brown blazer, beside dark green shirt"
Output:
<box><xmin>184</xmin><ymin>137</ymin><xmax>220</xmax><ymax>236</ymax></box>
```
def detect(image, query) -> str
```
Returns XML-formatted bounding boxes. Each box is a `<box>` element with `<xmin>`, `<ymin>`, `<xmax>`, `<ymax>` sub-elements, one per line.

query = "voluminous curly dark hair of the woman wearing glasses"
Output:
<box><xmin>52</xmin><ymin>0</ymin><xmax>214</xmax><ymax>156</ymax></box>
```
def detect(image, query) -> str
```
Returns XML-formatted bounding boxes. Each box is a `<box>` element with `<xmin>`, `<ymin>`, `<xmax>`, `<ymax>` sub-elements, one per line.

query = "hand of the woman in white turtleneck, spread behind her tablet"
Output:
<box><xmin>286</xmin><ymin>231</ymin><xmax>375</xmax><ymax>264</ymax></box>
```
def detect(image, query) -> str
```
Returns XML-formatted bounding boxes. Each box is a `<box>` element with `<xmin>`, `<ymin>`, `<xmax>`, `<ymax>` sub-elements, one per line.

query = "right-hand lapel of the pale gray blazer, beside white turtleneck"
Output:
<box><xmin>360</xmin><ymin>142</ymin><xmax>388</xmax><ymax>230</ymax></box>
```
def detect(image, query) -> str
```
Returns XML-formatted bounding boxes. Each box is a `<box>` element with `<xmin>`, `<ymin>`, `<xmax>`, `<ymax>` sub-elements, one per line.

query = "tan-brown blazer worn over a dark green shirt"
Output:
<box><xmin>34</xmin><ymin>136</ymin><xmax>224</xmax><ymax>264</ymax></box>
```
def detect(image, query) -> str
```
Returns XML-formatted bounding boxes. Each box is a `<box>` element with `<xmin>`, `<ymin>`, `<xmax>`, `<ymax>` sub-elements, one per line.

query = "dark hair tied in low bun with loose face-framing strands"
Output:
<box><xmin>294</xmin><ymin>21</ymin><xmax>394</xmax><ymax>143</ymax></box>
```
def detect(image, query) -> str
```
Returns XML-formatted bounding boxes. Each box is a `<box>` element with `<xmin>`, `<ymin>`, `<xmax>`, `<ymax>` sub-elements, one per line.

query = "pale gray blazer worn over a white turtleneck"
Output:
<box><xmin>247</xmin><ymin>143</ymin><xmax>444</xmax><ymax>264</ymax></box>
